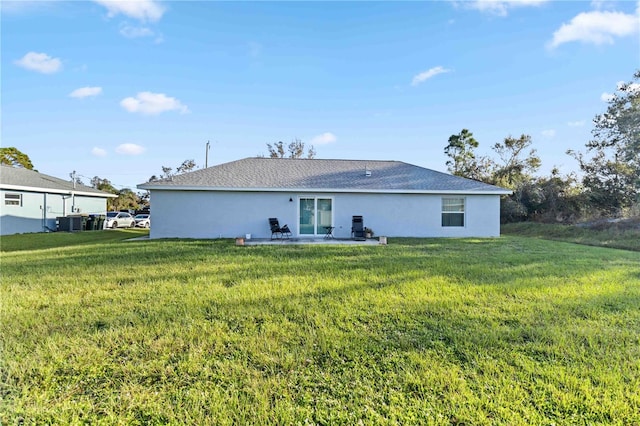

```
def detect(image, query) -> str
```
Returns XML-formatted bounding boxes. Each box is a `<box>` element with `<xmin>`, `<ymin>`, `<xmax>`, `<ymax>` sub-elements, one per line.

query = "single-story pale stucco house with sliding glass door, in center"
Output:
<box><xmin>138</xmin><ymin>158</ymin><xmax>511</xmax><ymax>238</ymax></box>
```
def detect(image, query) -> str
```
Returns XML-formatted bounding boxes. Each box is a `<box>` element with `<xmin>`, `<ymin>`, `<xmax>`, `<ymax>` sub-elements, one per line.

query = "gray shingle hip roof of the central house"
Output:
<box><xmin>138</xmin><ymin>157</ymin><xmax>510</xmax><ymax>194</ymax></box>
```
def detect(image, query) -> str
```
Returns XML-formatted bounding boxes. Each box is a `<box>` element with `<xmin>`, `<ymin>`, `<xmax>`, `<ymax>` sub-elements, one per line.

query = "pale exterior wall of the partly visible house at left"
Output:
<box><xmin>0</xmin><ymin>189</ymin><xmax>107</xmax><ymax>235</ymax></box>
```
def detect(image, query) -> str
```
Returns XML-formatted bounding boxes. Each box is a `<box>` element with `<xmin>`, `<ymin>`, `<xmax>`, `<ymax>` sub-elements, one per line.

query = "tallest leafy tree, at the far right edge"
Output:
<box><xmin>567</xmin><ymin>70</ymin><xmax>640</xmax><ymax>215</ymax></box>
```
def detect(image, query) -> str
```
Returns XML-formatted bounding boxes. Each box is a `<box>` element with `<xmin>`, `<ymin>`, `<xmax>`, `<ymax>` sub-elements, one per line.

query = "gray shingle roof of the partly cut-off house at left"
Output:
<box><xmin>0</xmin><ymin>164</ymin><xmax>115</xmax><ymax>197</ymax></box>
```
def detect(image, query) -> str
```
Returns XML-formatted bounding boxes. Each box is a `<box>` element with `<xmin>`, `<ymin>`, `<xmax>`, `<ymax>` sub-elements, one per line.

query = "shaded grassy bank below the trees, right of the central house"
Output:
<box><xmin>501</xmin><ymin>221</ymin><xmax>640</xmax><ymax>251</ymax></box>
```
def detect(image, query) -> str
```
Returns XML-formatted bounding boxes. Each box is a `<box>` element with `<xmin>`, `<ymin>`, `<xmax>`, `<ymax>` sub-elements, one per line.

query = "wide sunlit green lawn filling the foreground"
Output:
<box><xmin>0</xmin><ymin>235</ymin><xmax>640</xmax><ymax>425</ymax></box>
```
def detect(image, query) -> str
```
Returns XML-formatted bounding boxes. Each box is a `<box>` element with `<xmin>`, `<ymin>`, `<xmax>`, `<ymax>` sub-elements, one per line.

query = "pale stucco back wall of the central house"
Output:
<box><xmin>150</xmin><ymin>190</ymin><xmax>500</xmax><ymax>238</ymax></box>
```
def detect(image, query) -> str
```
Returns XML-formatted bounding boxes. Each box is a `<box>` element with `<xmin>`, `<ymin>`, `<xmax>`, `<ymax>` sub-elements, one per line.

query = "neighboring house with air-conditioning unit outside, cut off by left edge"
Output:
<box><xmin>0</xmin><ymin>164</ymin><xmax>116</xmax><ymax>235</ymax></box>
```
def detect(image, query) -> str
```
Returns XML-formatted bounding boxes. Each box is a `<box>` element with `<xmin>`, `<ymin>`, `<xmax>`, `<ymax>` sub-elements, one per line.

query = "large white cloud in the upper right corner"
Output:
<box><xmin>548</xmin><ymin>10</ymin><xmax>640</xmax><ymax>49</ymax></box>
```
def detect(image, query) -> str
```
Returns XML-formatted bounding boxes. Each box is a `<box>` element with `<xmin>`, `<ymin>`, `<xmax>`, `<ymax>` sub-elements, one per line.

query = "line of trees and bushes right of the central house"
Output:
<box><xmin>444</xmin><ymin>70</ymin><xmax>640</xmax><ymax>222</ymax></box>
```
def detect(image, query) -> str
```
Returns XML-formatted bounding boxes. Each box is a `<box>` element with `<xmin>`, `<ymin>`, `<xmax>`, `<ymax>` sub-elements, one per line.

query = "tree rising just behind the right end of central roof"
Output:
<box><xmin>444</xmin><ymin>129</ymin><xmax>490</xmax><ymax>181</ymax></box>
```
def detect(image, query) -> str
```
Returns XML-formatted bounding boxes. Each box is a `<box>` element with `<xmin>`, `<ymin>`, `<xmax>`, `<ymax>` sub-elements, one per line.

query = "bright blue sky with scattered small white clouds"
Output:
<box><xmin>1</xmin><ymin>0</ymin><xmax>640</xmax><ymax>189</ymax></box>
